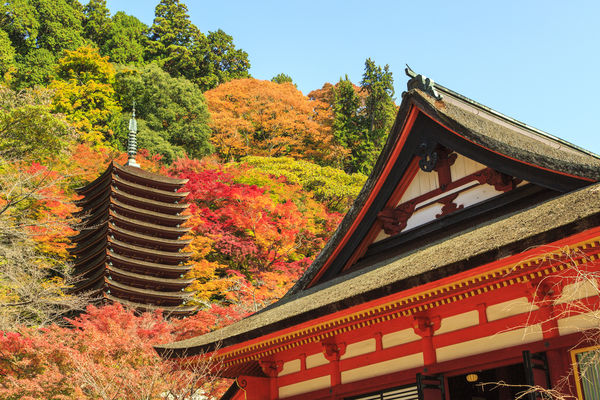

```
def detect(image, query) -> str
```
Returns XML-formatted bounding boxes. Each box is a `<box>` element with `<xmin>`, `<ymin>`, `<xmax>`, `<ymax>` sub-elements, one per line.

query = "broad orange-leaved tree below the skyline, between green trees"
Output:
<box><xmin>205</xmin><ymin>79</ymin><xmax>346</xmax><ymax>165</ymax></box>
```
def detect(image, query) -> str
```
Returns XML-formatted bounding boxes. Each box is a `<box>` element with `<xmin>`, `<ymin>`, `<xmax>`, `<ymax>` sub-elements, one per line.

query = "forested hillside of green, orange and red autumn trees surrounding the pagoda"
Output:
<box><xmin>0</xmin><ymin>0</ymin><xmax>397</xmax><ymax>399</ymax></box>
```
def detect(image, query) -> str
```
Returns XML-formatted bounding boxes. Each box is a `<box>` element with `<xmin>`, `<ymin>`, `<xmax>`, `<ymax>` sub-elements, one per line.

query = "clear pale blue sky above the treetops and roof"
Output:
<box><xmin>107</xmin><ymin>0</ymin><xmax>600</xmax><ymax>154</ymax></box>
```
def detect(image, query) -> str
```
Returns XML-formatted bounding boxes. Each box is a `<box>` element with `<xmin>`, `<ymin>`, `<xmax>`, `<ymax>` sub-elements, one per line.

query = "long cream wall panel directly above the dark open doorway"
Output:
<box><xmin>436</xmin><ymin>325</ymin><xmax>543</xmax><ymax>362</ymax></box>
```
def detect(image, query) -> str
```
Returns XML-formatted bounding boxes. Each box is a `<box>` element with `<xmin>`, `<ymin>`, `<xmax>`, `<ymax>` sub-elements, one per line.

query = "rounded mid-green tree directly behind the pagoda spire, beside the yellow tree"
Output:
<box><xmin>115</xmin><ymin>64</ymin><xmax>212</xmax><ymax>162</ymax></box>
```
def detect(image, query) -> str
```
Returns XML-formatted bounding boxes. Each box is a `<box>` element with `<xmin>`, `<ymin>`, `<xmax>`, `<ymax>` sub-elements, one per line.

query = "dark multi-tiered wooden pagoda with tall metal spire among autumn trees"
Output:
<box><xmin>71</xmin><ymin>110</ymin><xmax>195</xmax><ymax>314</ymax></box>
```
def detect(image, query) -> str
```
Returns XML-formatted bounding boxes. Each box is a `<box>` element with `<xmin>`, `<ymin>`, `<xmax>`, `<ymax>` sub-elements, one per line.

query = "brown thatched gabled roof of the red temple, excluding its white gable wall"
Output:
<box><xmin>157</xmin><ymin>73</ymin><xmax>600</xmax><ymax>357</ymax></box>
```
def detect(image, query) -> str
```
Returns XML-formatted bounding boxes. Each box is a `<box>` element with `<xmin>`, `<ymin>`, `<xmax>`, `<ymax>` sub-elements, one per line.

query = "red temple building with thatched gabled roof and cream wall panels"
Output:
<box><xmin>157</xmin><ymin>70</ymin><xmax>600</xmax><ymax>400</ymax></box>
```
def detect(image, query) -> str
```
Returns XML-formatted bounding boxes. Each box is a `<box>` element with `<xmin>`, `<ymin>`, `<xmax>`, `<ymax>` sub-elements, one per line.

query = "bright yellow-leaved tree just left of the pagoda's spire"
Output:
<box><xmin>50</xmin><ymin>47</ymin><xmax>121</xmax><ymax>146</ymax></box>
